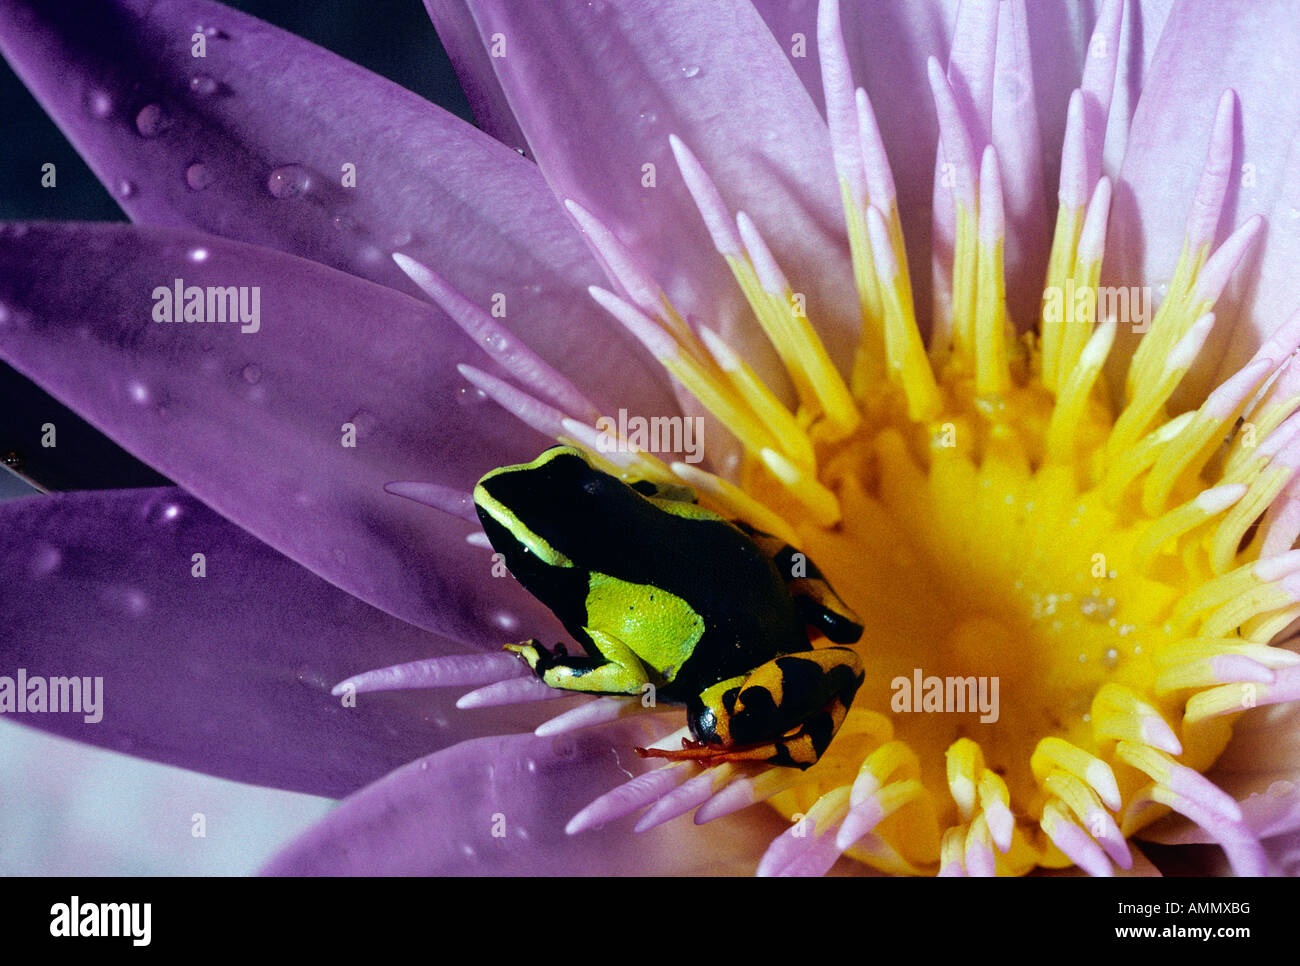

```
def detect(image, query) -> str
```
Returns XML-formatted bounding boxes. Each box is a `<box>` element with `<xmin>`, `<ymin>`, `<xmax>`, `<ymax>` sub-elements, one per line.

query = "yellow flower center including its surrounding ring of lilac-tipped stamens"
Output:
<box><xmin>564</xmin><ymin>113</ymin><xmax>1300</xmax><ymax>874</ymax></box>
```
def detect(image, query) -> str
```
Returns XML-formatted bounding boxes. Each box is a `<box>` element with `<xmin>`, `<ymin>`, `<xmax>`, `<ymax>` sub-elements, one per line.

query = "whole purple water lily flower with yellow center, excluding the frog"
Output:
<box><xmin>0</xmin><ymin>0</ymin><xmax>1300</xmax><ymax>875</ymax></box>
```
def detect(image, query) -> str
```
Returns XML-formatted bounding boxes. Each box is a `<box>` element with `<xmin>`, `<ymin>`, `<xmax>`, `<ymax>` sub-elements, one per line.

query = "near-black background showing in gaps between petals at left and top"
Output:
<box><xmin>0</xmin><ymin>0</ymin><xmax>471</xmax><ymax>501</ymax></box>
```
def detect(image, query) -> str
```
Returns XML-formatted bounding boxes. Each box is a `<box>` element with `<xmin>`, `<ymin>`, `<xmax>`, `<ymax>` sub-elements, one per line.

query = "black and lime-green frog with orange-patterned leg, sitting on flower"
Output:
<box><xmin>473</xmin><ymin>446</ymin><xmax>865</xmax><ymax>770</ymax></box>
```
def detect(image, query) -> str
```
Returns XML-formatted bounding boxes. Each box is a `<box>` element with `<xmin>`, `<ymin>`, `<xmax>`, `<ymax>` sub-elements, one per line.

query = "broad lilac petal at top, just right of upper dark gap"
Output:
<box><xmin>452</xmin><ymin>0</ymin><xmax>857</xmax><ymax>384</ymax></box>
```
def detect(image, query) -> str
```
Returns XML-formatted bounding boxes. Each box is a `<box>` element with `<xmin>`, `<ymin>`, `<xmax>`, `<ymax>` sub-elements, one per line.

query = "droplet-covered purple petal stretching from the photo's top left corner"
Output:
<box><xmin>0</xmin><ymin>0</ymin><xmax>673</xmax><ymax>412</ymax></box>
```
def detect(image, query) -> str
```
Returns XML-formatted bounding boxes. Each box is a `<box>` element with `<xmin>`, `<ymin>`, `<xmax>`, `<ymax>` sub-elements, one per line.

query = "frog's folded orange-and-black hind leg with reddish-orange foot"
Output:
<box><xmin>638</xmin><ymin>647</ymin><xmax>865</xmax><ymax>768</ymax></box>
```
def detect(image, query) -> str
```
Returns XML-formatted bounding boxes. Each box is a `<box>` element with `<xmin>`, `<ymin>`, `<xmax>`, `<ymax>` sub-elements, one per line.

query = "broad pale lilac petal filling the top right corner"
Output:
<box><xmin>1108</xmin><ymin>0</ymin><xmax>1300</xmax><ymax>400</ymax></box>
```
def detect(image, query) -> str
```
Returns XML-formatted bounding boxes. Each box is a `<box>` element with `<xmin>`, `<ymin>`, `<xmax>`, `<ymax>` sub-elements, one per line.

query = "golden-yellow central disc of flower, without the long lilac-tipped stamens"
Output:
<box><xmin>744</xmin><ymin>309</ymin><xmax>1288</xmax><ymax>874</ymax></box>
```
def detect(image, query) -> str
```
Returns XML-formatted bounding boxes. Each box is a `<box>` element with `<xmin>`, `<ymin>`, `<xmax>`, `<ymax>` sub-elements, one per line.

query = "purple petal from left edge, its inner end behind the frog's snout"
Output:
<box><xmin>0</xmin><ymin>225</ymin><xmax>556</xmax><ymax>642</ymax></box>
